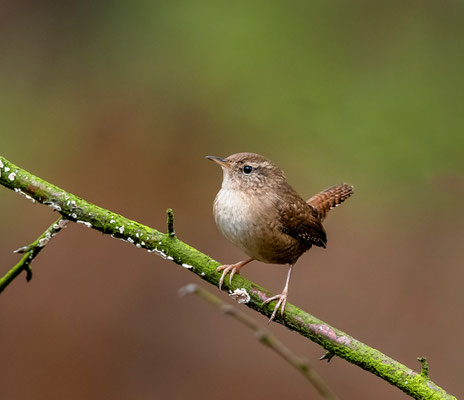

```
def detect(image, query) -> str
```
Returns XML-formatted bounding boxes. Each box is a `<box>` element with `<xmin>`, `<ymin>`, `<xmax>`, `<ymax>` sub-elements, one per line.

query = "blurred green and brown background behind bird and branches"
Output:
<box><xmin>0</xmin><ymin>0</ymin><xmax>464</xmax><ymax>400</ymax></box>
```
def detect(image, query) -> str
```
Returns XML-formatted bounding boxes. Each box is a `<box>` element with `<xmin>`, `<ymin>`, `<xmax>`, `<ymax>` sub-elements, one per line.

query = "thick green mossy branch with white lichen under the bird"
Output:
<box><xmin>0</xmin><ymin>156</ymin><xmax>456</xmax><ymax>400</ymax></box>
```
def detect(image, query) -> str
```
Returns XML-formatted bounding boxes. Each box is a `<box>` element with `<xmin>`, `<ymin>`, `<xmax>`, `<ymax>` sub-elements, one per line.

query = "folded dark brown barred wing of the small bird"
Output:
<box><xmin>279</xmin><ymin>199</ymin><xmax>327</xmax><ymax>248</ymax></box>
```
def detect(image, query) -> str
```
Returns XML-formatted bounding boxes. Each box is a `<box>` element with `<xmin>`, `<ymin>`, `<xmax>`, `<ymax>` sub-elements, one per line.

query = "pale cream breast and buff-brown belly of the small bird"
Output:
<box><xmin>214</xmin><ymin>189</ymin><xmax>301</xmax><ymax>264</ymax></box>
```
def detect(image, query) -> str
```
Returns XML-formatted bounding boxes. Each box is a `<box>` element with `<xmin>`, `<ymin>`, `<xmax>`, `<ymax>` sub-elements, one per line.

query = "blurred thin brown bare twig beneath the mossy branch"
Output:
<box><xmin>179</xmin><ymin>283</ymin><xmax>340</xmax><ymax>400</ymax></box>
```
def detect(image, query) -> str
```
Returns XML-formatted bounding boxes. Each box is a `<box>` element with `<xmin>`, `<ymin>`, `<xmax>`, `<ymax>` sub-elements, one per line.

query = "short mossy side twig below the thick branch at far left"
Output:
<box><xmin>0</xmin><ymin>217</ymin><xmax>68</xmax><ymax>293</ymax></box>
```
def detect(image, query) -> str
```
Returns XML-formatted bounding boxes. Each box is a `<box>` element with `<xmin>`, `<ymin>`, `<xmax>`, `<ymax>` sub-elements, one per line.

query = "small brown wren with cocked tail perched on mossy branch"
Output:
<box><xmin>206</xmin><ymin>153</ymin><xmax>353</xmax><ymax>321</ymax></box>
